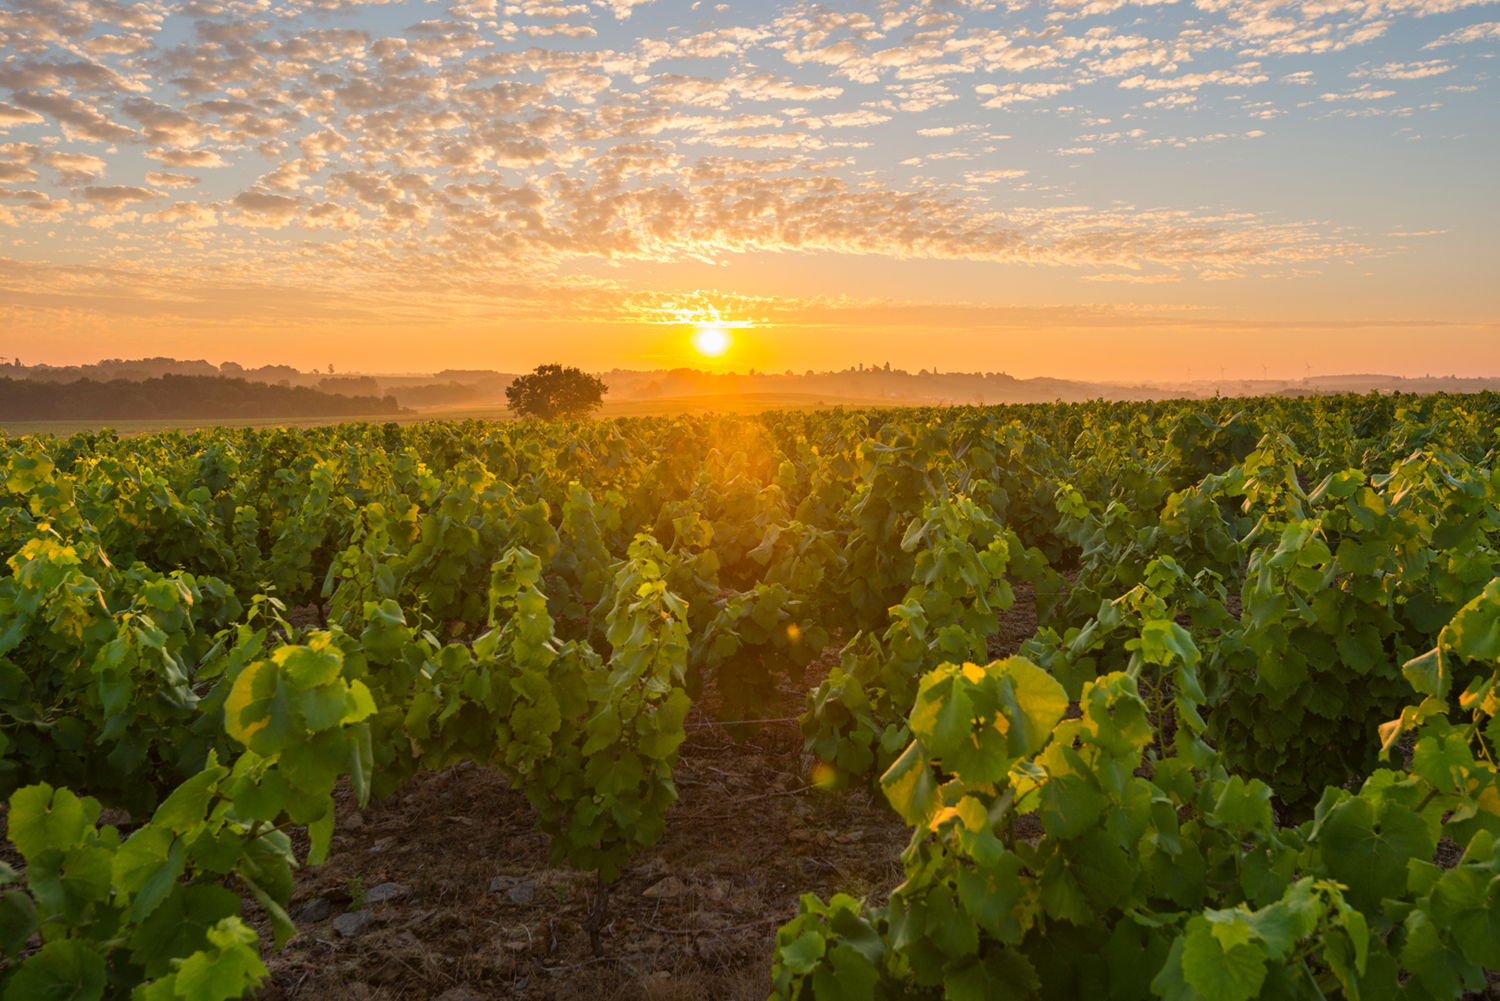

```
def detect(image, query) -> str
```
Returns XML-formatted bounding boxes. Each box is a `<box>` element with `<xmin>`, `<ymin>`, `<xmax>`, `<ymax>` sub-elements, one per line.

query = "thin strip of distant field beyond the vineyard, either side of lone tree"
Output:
<box><xmin>0</xmin><ymin>393</ymin><xmax>915</xmax><ymax>438</ymax></box>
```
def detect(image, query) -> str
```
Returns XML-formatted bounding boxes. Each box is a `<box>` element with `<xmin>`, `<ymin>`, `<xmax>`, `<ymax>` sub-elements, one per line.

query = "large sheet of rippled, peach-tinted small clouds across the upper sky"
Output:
<box><xmin>0</xmin><ymin>0</ymin><xmax>1464</xmax><ymax>325</ymax></box>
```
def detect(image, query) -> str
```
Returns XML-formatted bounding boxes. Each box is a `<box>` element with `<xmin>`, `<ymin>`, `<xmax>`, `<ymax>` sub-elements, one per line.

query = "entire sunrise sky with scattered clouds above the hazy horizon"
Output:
<box><xmin>0</xmin><ymin>0</ymin><xmax>1500</xmax><ymax>381</ymax></box>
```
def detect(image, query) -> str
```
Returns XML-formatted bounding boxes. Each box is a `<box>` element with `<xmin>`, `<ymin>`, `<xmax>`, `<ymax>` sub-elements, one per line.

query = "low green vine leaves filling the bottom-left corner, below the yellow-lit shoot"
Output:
<box><xmin>0</xmin><ymin>755</ymin><xmax>297</xmax><ymax>1001</ymax></box>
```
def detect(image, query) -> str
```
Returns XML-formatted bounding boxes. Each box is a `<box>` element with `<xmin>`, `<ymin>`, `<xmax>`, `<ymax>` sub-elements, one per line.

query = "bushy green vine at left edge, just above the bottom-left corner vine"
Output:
<box><xmin>0</xmin><ymin>531</ymin><xmax>242</xmax><ymax>812</ymax></box>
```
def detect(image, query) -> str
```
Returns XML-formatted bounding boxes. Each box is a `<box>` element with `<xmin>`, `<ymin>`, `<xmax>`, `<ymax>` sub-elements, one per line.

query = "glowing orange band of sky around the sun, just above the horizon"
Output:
<box><xmin>5</xmin><ymin>255</ymin><xmax>1500</xmax><ymax>380</ymax></box>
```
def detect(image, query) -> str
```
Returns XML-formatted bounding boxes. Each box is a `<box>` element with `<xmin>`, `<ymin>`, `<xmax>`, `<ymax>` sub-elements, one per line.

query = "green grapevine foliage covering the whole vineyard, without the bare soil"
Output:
<box><xmin>0</xmin><ymin>396</ymin><xmax>1500</xmax><ymax>998</ymax></box>
